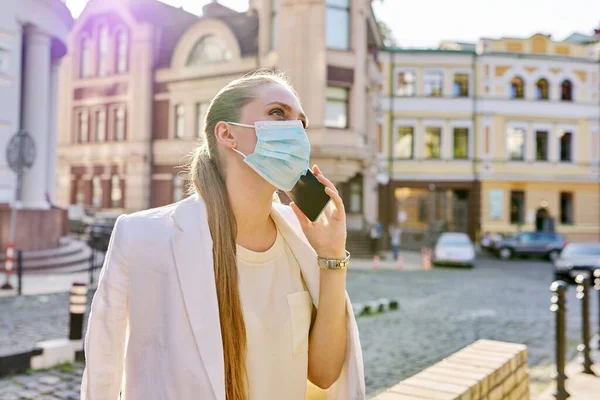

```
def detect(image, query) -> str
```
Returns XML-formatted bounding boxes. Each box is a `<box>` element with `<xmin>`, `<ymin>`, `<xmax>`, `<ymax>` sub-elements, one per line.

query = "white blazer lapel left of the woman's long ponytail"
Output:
<box><xmin>171</xmin><ymin>195</ymin><xmax>225</xmax><ymax>400</ymax></box>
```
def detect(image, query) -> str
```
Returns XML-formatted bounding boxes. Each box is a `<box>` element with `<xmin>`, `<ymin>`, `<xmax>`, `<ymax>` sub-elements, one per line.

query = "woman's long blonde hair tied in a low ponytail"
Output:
<box><xmin>187</xmin><ymin>71</ymin><xmax>296</xmax><ymax>400</ymax></box>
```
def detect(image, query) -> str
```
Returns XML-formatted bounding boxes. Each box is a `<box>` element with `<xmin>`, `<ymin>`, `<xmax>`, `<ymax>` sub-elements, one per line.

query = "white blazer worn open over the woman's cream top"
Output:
<box><xmin>81</xmin><ymin>196</ymin><xmax>365</xmax><ymax>400</ymax></box>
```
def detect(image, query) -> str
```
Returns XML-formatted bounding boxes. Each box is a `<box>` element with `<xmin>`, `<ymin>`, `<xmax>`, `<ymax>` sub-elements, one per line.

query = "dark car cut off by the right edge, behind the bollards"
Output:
<box><xmin>554</xmin><ymin>243</ymin><xmax>600</xmax><ymax>283</ymax></box>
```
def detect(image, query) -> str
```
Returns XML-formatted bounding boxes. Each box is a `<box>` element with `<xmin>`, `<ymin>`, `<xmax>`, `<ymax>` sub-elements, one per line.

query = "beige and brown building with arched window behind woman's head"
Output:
<box><xmin>58</xmin><ymin>0</ymin><xmax>381</xmax><ymax>234</ymax></box>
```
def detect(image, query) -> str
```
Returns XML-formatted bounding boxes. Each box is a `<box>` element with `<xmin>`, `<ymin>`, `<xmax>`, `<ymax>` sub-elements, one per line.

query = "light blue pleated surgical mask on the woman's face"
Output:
<box><xmin>228</xmin><ymin>120</ymin><xmax>310</xmax><ymax>192</ymax></box>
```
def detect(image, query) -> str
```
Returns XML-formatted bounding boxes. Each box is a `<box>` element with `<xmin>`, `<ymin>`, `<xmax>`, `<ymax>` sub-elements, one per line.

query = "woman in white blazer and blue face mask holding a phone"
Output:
<box><xmin>81</xmin><ymin>72</ymin><xmax>365</xmax><ymax>400</ymax></box>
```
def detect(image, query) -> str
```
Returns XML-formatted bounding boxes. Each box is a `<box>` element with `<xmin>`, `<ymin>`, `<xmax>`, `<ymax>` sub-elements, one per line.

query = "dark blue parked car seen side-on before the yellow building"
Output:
<box><xmin>494</xmin><ymin>232</ymin><xmax>567</xmax><ymax>261</ymax></box>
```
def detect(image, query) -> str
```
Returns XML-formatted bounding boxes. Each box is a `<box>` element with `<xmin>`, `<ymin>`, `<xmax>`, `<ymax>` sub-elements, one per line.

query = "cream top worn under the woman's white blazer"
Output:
<box><xmin>237</xmin><ymin>231</ymin><xmax>312</xmax><ymax>400</ymax></box>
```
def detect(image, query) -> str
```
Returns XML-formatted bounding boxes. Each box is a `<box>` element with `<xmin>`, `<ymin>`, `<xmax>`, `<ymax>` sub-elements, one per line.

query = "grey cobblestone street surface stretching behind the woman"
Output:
<box><xmin>0</xmin><ymin>259</ymin><xmax>600</xmax><ymax>400</ymax></box>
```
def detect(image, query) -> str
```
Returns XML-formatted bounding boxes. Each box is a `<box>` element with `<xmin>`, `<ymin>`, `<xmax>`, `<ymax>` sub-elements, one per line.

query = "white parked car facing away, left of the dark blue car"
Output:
<box><xmin>433</xmin><ymin>232</ymin><xmax>475</xmax><ymax>268</ymax></box>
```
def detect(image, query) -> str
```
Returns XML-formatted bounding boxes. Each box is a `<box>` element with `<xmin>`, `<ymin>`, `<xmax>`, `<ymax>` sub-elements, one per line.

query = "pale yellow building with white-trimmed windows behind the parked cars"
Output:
<box><xmin>378</xmin><ymin>34</ymin><xmax>600</xmax><ymax>241</ymax></box>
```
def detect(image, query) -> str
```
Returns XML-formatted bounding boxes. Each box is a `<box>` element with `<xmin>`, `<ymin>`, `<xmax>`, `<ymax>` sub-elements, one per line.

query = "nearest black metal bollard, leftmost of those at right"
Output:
<box><xmin>550</xmin><ymin>281</ymin><xmax>571</xmax><ymax>400</ymax></box>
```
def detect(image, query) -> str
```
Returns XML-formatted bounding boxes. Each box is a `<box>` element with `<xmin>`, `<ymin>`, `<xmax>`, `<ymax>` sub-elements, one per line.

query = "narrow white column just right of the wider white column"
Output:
<box><xmin>46</xmin><ymin>60</ymin><xmax>59</xmax><ymax>203</ymax></box>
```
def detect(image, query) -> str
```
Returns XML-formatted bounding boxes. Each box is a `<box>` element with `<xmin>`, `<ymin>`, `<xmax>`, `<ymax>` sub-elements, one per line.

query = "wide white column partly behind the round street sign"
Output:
<box><xmin>22</xmin><ymin>26</ymin><xmax>50</xmax><ymax>209</ymax></box>
